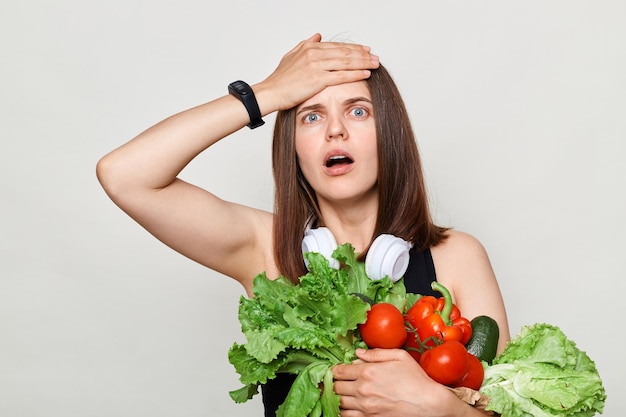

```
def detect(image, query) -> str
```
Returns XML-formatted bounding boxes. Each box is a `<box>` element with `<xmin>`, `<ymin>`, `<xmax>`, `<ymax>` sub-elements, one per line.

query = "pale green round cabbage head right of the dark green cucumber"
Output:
<box><xmin>480</xmin><ymin>323</ymin><xmax>606</xmax><ymax>417</ymax></box>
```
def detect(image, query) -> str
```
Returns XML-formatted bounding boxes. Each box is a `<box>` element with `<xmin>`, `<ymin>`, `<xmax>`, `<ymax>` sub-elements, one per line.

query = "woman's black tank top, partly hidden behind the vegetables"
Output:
<box><xmin>261</xmin><ymin>249</ymin><xmax>440</xmax><ymax>417</ymax></box>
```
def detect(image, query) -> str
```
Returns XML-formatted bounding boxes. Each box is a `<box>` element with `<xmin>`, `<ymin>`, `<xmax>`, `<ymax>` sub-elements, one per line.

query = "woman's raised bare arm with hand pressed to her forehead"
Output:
<box><xmin>97</xmin><ymin>34</ymin><xmax>378</xmax><ymax>290</ymax></box>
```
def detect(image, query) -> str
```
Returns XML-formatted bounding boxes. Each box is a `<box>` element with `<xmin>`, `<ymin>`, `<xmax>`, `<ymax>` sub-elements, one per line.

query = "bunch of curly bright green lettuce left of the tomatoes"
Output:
<box><xmin>228</xmin><ymin>243</ymin><xmax>419</xmax><ymax>417</ymax></box>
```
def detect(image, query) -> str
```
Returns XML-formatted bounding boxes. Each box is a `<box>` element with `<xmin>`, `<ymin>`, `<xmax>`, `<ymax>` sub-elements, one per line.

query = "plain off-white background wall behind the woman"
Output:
<box><xmin>0</xmin><ymin>0</ymin><xmax>626</xmax><ymax>417</ymax></box>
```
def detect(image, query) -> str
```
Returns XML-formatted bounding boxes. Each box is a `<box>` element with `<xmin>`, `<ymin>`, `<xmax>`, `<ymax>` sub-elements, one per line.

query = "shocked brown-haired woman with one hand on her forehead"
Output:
<box><xmin>97</xmin><ymin>34</ymin><xmax>509</xmax><ymax>417</ymax></box>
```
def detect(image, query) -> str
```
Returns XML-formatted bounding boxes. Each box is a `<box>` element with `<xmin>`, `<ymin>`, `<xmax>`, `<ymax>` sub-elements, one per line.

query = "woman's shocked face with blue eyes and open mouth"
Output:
<box><xmin>296</xmin><ymin>81</ymin><xmax>378</xmax><ymax>203</ymax></box>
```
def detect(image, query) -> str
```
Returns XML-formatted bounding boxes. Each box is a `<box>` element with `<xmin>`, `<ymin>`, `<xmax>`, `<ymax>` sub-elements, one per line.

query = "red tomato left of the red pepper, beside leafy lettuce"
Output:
<box><xmin>359</xmin><ymin>303</ymin><xmax>406</xmax><ymax>349</ymax></box>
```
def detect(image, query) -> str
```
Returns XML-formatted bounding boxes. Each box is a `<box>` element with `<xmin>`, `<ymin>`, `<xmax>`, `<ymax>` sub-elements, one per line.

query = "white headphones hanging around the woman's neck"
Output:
<box><xmin>302</xmin><ymin>227</ymin><xmax>412</xmax><ymax>282</ymax></box>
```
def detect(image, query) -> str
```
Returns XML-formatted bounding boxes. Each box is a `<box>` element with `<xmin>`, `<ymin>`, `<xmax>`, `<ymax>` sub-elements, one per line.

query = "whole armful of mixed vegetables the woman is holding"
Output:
<box><xmin>228</xmin><ymin>244</ymin><xmax>606</xmax><ymax>417</ymax></box>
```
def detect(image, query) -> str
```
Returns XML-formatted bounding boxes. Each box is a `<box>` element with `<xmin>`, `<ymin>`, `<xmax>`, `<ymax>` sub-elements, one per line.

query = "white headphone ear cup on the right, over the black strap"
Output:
<box><xmin>365</xmin><ymin>234</ymin><xmax>411</xmax><ymax>282</ymax></box>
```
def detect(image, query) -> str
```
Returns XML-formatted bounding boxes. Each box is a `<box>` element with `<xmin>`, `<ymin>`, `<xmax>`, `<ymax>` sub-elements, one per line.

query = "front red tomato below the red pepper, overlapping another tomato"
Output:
<box><xmin>420</xmin><ymin>340</ymin><xmax>469</xmax><ymax>386</ymax></box>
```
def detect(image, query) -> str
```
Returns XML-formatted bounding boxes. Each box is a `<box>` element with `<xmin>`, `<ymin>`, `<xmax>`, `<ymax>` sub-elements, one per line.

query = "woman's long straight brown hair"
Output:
<box><xmin>272</xmin><ymin>65</ymin><xmax>447</xmax><ymax>282</ymax></box>
